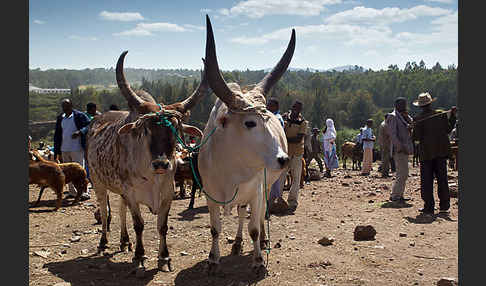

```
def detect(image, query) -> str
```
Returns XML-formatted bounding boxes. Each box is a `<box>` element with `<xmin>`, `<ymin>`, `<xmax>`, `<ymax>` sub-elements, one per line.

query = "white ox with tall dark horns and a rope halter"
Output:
<box><xmin>198</xmin><ymin>16</ymin><xmax>295</xmax><ymax>274</ymax></box>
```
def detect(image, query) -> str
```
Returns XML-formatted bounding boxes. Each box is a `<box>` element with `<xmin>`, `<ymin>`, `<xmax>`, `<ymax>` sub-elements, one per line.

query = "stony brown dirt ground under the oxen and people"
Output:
<box><xmin>29</xmin><ymin>161</ymin><xmax>458</xmax><ymax>286</ymax></box>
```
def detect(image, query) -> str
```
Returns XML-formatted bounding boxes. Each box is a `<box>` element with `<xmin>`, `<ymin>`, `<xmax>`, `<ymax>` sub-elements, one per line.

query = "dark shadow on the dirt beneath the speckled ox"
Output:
<box><xmin>44</xmin><ymin>252</ymin><xmax>158</xmax><ymax>286</ymax></box>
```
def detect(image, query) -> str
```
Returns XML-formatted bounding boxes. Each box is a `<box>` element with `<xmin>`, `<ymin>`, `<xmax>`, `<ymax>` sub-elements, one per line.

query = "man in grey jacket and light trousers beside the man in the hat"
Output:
<box><xmin>386</xmin><ymin>97</ymin><xmax>413</xmax><ymax>203</ymax></box>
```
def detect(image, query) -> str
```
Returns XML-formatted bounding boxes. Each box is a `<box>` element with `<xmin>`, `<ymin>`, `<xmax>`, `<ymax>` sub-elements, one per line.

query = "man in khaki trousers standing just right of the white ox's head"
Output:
<box><xmin>280</xmin><ymin>100</ymin><xmax>308</xmax><ymax>212</ymax></box>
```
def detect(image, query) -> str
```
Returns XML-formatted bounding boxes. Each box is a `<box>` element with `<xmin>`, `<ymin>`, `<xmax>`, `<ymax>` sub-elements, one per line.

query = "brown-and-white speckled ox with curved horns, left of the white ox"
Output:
<box><xmin>87</xmin><ymin>52</ymin><xmax>209</xmax><ymax>274</ymax></box>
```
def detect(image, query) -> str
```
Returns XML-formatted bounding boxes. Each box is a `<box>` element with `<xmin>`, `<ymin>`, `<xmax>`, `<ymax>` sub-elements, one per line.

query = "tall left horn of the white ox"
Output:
<box><xmin>205</xmin><ymin>15</ymin><xmax>235</xmax><ymax>108</ymax></box>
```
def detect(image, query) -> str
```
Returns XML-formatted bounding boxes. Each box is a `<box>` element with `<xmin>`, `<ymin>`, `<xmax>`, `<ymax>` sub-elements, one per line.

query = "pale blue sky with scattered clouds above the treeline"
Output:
<box><xmin>29</xmin><ymin>0</ymin><xmax>458</xmax><ymax>70</ymax></box>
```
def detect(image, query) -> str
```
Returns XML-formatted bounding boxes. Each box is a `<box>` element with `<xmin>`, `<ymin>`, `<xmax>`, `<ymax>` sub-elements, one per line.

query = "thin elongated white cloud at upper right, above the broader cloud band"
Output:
<box><xmin>324</xmin><ymin>5</ymin><xmax>451</xmax><ymax>25</ymax></box>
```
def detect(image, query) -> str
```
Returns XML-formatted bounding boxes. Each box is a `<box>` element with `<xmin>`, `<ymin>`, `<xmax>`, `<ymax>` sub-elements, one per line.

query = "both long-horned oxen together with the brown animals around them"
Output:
<box><xmin>29</xmin><ymin>16</ymin><xmax>460</xmax><ymax>280</ymax></box>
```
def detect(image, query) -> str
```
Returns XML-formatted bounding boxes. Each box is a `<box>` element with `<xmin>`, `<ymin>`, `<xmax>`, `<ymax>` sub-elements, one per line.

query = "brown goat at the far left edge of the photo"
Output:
<box><xmin>29</xmin><ymin>150</ymin><xmax>66</xmax><ymax>211</ymax></box>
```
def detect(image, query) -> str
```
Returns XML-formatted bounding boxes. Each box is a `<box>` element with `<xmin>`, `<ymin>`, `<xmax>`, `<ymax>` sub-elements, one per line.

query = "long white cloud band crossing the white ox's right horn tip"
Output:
<box><xmin>230</xmin><ymin>7</ymin><xmax>458</xmax><ymax>53</ymax></box>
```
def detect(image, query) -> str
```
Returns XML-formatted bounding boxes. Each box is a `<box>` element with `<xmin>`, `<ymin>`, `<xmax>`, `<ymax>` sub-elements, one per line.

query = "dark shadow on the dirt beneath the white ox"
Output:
<box><xmin>174</xmin><ymin>252</ymin><xmax>267</xmax><ymax>286</ymax></box>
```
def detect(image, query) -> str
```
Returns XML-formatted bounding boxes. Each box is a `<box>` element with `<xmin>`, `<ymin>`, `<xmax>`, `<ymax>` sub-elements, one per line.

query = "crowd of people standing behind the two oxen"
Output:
<box><xmin>29</xmin><ymin>93</ymin><xmax>458</xmax><ymax>217</ymax></box>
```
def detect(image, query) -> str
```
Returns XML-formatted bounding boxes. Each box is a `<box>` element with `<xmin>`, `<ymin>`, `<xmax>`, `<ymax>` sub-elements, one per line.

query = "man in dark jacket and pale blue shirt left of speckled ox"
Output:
<box><xmin>54</xmin><ymin>98</ymin><xmax>90</xmax><ymax>200</ymax></box>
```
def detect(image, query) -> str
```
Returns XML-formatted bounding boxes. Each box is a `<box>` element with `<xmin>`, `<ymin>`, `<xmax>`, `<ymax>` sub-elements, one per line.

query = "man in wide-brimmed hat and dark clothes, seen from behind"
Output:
<box><xmin>412</xmin><ymin>92</ymin><xmax>456</xmax><ymax>214</ymax></box>
